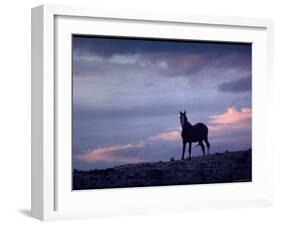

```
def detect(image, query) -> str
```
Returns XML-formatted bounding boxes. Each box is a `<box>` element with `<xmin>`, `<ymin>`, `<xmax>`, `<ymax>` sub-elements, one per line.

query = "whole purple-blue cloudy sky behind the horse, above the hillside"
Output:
<box><xmin>72</xmin><ymin>36</ymin><xmax>252</xmax><ymax>170</ymax></box>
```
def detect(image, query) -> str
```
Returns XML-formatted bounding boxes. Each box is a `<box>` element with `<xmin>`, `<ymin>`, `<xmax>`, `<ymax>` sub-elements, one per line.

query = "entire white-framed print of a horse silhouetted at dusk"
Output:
<box><xmin>32</xmin><ymin>5</ymin><xmax>273</xmax><ymax>220</ymax></box>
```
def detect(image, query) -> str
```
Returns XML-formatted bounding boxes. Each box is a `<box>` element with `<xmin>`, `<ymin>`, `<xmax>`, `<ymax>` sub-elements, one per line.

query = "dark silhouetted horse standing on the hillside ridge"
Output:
<box><xmin>180</xmin><ymin>111</ymin><xmax>210</xmax><ymax>160</ymax></box>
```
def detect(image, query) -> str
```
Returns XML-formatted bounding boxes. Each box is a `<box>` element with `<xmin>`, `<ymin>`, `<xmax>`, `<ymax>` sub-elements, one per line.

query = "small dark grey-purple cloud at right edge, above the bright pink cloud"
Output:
<box><xmin>218</xmin><ymin>76</ymin><xmax>252</xmax><ymax>93</ymax></box>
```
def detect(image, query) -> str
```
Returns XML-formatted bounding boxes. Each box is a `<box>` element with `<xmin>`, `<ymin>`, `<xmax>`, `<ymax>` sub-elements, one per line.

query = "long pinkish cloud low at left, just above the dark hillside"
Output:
<box><xmin>75</xmin><ymin>143</ymin><xmax>144</xmax><ymax>163</ymax></box>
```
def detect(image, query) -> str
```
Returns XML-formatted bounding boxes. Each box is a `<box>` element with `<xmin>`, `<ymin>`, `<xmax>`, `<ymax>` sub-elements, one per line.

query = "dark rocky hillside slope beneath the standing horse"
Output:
<box><xmin>73</xmin><ymin>149</ymin><xmax>249</xmax><ymax>190</ymax></box>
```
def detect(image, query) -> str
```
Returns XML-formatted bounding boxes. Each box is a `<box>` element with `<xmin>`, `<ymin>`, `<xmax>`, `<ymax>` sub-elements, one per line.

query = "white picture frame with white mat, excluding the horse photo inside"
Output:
<box><xmin>31</xmin><ymin>5</ymin><xmax>273</xmax><ymax>220</ymax></box>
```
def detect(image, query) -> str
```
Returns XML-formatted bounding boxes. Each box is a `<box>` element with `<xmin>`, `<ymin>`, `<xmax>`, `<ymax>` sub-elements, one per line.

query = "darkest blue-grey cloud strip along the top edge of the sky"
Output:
<box><xmin>73</xmin><ymin>36</ymin><xmax>251</xmax><ymax>57</ymax></box>
